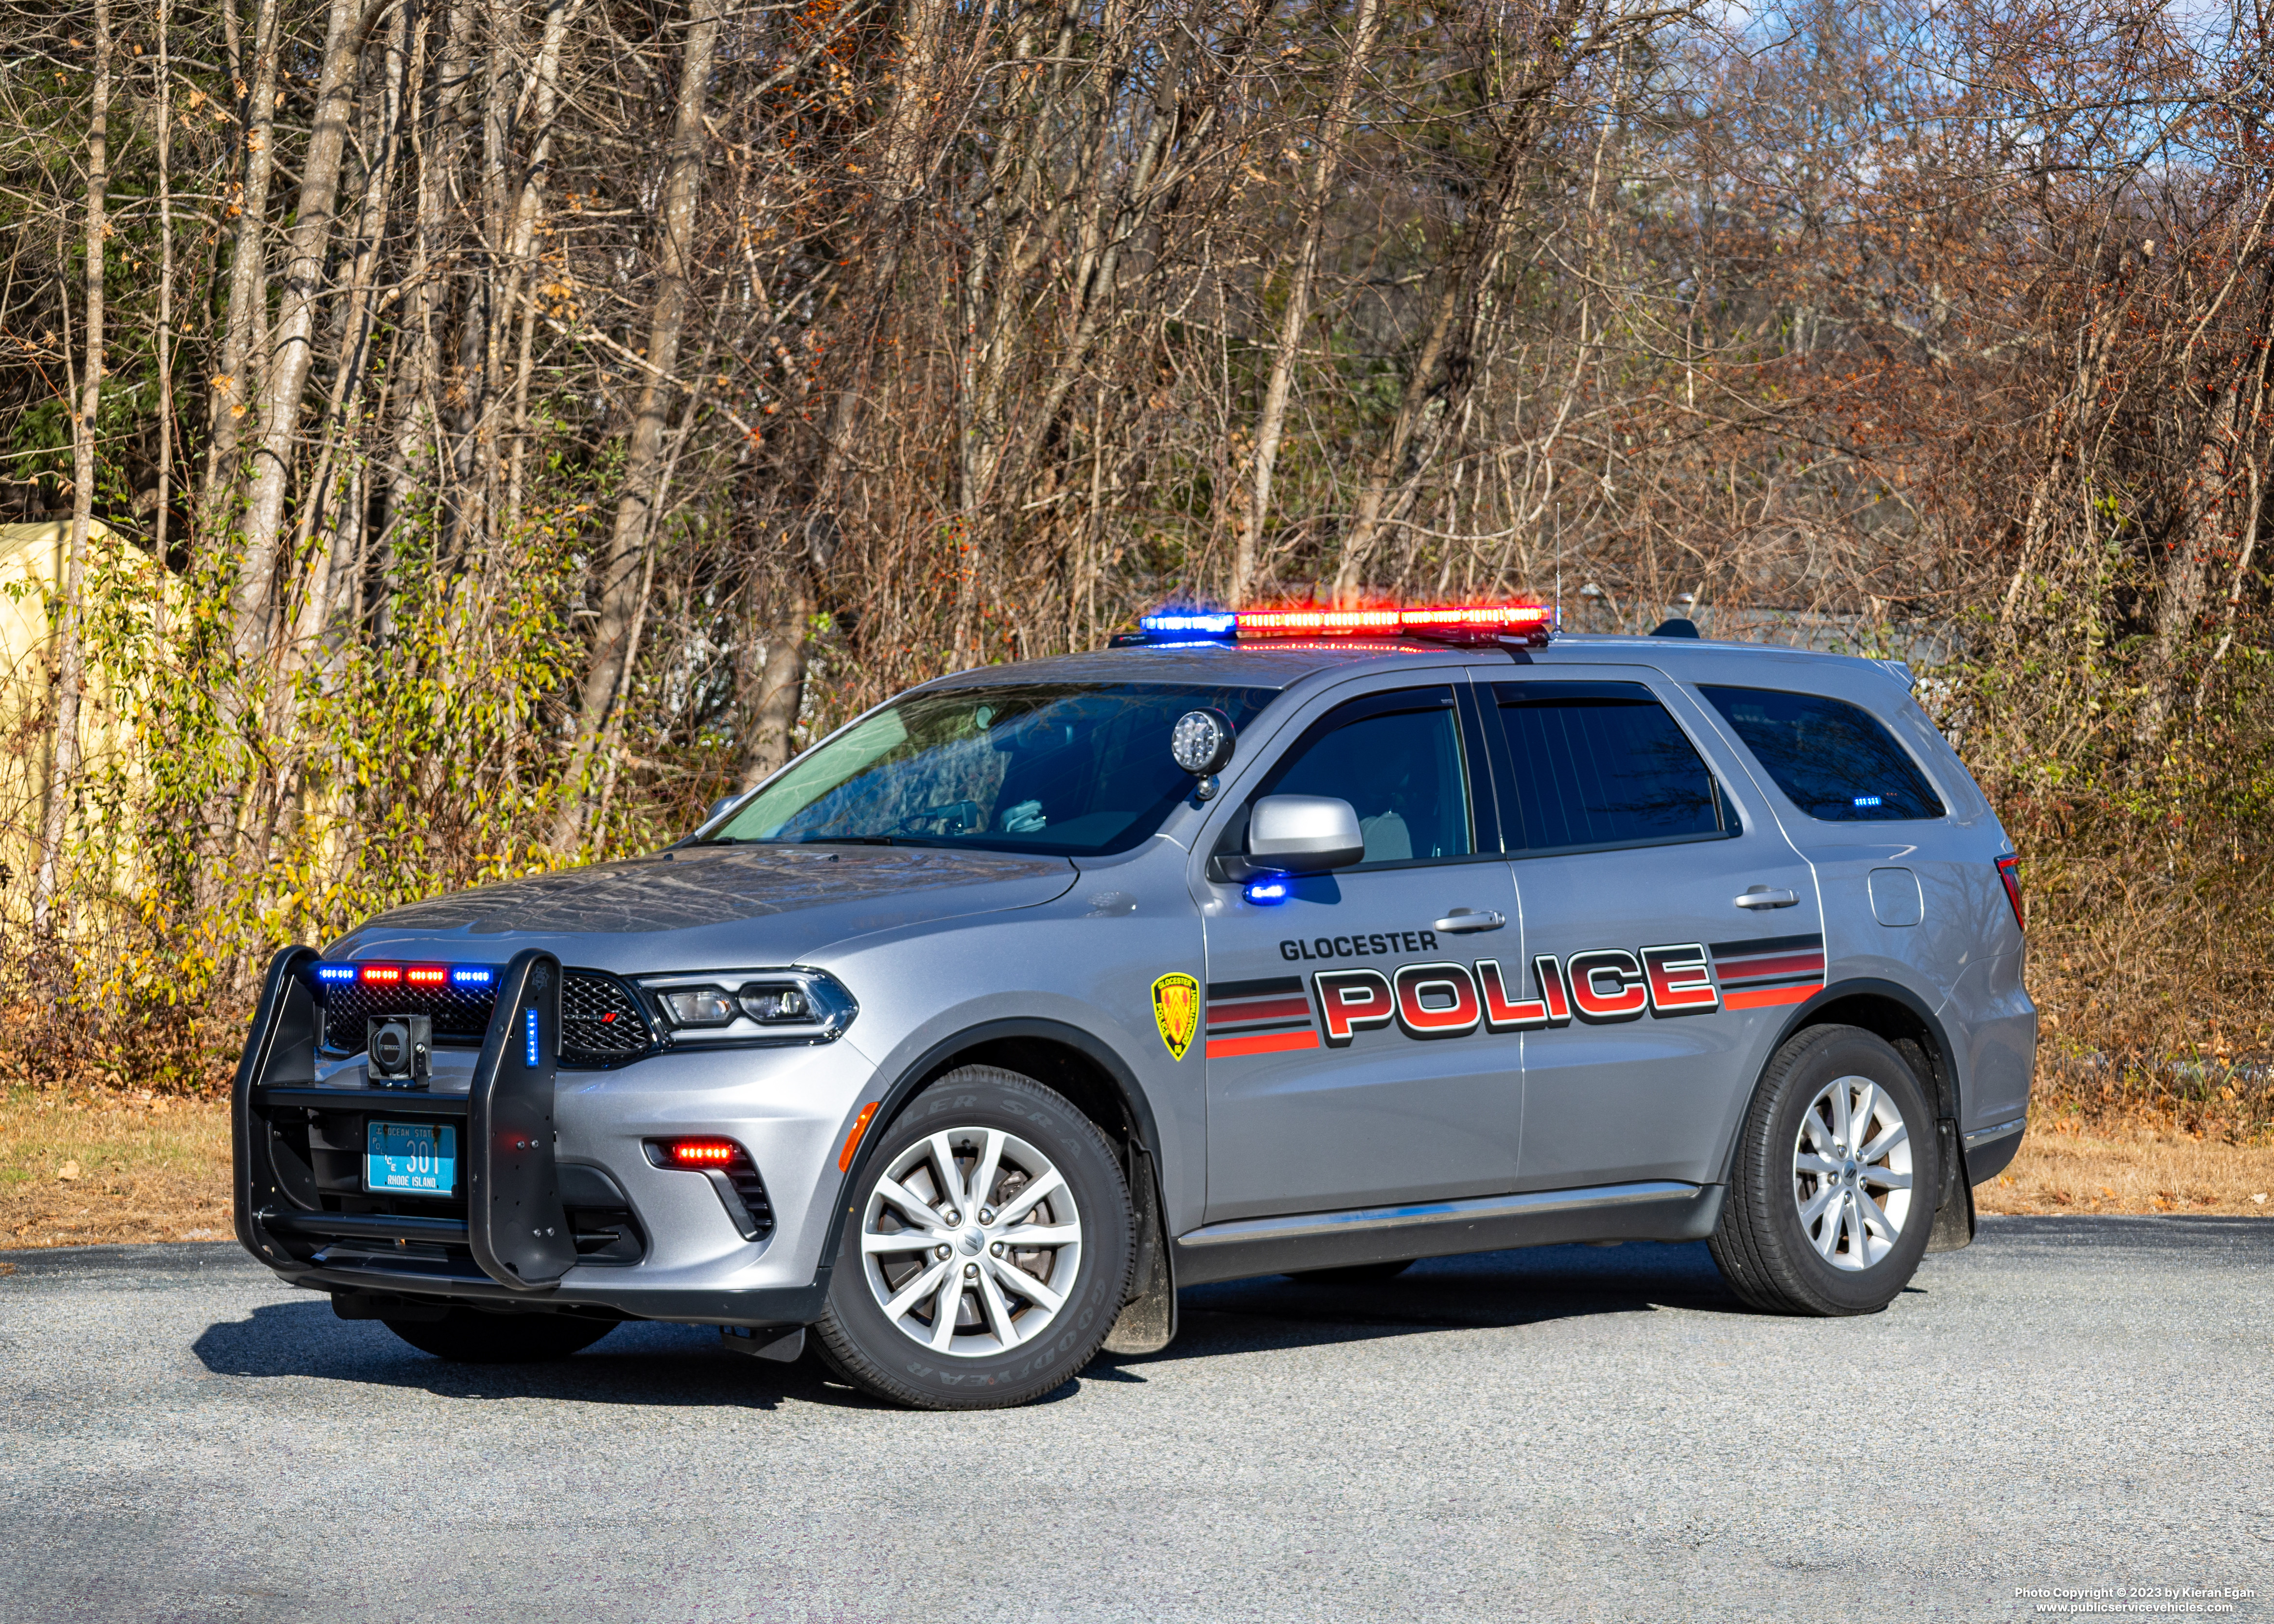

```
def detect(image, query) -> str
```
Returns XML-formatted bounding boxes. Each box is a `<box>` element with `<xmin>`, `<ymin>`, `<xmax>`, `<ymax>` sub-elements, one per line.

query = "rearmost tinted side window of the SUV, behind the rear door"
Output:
<box><xmin>1698</xmin><ymin>687</ymin><xmax>1944</xmax><ymax>823</ymax></box>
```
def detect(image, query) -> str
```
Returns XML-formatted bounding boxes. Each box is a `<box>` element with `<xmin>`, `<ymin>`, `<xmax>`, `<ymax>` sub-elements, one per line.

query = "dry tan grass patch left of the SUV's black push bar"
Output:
<box><xmin>0</xmin><ymin>1089</ymin><xmax>234</xmax><ymax>1249</ymax></box>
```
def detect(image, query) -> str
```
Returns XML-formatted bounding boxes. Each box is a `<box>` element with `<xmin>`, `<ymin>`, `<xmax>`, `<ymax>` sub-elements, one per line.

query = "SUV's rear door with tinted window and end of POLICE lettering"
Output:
<box><xmin>1478</xmin><ymin>666</ymin><xmax>1824</xmax><ymax>1189</ymax></box>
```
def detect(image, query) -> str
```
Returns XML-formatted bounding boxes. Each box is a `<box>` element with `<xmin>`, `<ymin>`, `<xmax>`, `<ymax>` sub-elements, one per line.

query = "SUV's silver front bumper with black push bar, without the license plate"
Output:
<box><xmin>234</xmin><ymin>948</ymin><xmax>871</xmax><ymax>1328</ymax></box>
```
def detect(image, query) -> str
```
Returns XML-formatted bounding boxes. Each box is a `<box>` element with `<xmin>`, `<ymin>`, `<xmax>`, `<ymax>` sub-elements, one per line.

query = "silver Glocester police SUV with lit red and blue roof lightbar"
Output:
<box><xmin>234</xmin><ymin>607</ymin><xmax>2037</xmax><ymax>1408</ymax></box>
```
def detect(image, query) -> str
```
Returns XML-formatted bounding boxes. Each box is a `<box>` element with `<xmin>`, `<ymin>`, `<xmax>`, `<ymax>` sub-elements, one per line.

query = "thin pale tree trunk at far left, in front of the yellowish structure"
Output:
<box><xmin>32</xmin><ymin>0</ymin><xmax>111</xmax><ymax>937</ymax></box>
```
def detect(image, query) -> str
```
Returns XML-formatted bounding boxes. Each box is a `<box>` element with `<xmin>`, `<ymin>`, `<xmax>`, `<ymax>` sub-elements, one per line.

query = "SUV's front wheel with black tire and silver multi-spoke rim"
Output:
<box><xmin>814</xmin><ymin>1067</ymin><xmax>1135</xmax><ymax>1410</ymax></box>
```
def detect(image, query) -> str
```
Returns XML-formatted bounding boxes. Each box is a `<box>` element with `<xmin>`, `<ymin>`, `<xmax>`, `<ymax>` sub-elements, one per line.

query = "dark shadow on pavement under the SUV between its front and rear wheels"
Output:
<box><xmin>1109</xmin><ymin>1242</ymin><xmax>1753</xmax><ymax>1380</ymax></box>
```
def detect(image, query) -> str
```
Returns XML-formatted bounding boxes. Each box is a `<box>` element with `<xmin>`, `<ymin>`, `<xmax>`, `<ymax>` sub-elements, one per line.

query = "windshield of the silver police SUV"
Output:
<box><xmin>707</xmin><ymin>682</ymin><xmax>1274</xmax><ymax>857</ymax></box>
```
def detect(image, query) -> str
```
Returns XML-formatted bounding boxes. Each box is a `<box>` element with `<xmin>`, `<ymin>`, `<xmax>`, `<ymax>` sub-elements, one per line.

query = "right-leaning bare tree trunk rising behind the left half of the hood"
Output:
<box><xmin>553</xmin><ymin>0</ymin><xmax>723</xmax><ymax>851</ymax></box>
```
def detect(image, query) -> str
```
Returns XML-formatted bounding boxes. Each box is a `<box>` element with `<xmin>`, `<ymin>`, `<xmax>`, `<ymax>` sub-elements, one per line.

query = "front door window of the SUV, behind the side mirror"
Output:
<box><xmin>1264</xmin><ymin>689</ymin><xmax>1476</xmax><ymax>862</ymax></box>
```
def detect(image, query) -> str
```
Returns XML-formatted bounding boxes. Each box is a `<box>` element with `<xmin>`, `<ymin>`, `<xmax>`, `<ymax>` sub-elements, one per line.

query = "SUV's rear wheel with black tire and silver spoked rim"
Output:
<box><xmin>1708</xmin><ymin>1026</ymin><xmax>1942</xmax><ymax>1315</ymax></box>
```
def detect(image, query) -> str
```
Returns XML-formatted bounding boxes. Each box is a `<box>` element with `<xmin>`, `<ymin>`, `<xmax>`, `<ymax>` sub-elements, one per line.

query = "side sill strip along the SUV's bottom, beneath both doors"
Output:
<box><xmin>1176</xmin><ymin>1181</ymin><xmax>1724</xmax><ymax>1285</ymax></box>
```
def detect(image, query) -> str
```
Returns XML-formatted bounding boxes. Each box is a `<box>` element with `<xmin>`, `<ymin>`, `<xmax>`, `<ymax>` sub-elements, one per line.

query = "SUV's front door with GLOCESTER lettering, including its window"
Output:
<box><xmin>1203</xmin><ymin>676</ymin><xmax>1522</xmax><ymax>1222</ymax></box>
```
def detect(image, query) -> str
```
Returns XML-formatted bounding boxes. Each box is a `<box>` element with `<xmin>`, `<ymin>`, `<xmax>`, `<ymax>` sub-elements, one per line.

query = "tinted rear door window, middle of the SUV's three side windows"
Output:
<box><xmin>1494</xmin><ymin>682</ymin><xmax>1737</xmax><ymax>851</ymax></box>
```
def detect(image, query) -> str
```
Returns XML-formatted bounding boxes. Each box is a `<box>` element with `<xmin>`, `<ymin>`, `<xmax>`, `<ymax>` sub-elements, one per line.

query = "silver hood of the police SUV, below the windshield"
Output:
<box><xmin>325</xmin><ymin>846</ymin><xmax>1076</xmax><ymax>974</ymax></box>
